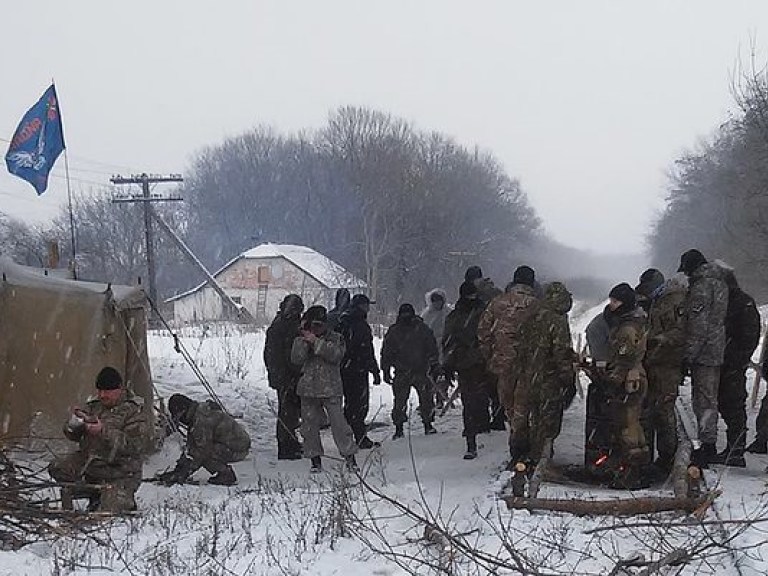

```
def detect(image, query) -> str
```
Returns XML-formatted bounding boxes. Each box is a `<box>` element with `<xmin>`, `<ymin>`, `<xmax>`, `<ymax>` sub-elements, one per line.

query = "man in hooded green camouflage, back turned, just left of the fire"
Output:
<box><xmin>511</xmin><ymin>282</ymin><xmax>576</xmax><ymax>461</ymax></box>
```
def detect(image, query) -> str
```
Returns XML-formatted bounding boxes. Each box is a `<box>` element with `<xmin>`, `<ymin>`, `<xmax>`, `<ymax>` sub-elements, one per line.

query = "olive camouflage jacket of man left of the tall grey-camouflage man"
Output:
<box><xmin>645</xmin><ymin>276</ymin><xmax>688</xmax><ymax>368</ymax></box>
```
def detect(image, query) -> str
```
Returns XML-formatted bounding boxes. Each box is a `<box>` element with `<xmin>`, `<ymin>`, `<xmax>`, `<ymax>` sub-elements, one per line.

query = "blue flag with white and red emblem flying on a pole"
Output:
<box><xmin>5</xmin><ymin>84</ymin><xmax>65</xmax><ymax>196</ymax></box>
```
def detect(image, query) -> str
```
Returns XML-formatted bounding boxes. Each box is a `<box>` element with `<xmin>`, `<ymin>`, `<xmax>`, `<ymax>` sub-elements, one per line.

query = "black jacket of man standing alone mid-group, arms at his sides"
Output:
<box><xmin>381</xmin><ymin>316</ymin><xmax>438</xmax><ymax>376</ymax></box>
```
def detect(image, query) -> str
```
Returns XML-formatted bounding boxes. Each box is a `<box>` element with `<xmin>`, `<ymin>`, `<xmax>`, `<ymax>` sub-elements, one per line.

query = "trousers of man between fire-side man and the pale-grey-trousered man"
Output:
<box><xmin>646</xmin><ymin>366</ymin><xmax>683</xmax><ymax>465</ymax></box>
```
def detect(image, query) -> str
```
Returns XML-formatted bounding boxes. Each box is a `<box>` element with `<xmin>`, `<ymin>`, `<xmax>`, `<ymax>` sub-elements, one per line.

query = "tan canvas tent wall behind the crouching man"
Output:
<box><xmin>0</xmin><ymin>258</ymin><xmax>153</xmax><ymax>444</ymax></box>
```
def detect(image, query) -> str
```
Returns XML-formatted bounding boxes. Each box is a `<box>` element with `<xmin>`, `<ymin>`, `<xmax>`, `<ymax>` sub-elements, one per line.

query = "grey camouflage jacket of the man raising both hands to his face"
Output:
<box><xmin>291</xmin><ymin>332</ymin><xmax>346</xmax><ymax>398</ymax></box>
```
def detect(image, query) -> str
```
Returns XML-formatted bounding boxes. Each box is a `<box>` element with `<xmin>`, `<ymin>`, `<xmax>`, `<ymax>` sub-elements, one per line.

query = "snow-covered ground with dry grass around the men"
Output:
<box><xmin>0</xmin><ymin>305</ymin><xmax>768</xmax><ymax>576</ymax></box>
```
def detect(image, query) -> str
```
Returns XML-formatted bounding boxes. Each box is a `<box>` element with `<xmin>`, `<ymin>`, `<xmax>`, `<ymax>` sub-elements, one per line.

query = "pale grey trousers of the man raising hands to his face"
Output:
<box><xmin>301</xmin><ymin>396</ymin><xmax>357</xmax><ymax>458</ymax></box>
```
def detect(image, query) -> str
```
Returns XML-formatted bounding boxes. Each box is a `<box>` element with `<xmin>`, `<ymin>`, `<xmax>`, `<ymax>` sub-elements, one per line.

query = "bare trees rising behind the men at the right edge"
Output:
<box><xmin>649</xmin><ymin>67</ymin><xmax>768</xmax><ymax>300</ymax></box>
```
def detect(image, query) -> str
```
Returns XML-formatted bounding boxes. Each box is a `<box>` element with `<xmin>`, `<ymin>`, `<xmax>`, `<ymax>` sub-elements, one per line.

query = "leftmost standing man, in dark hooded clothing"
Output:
<box><xmin>264</xmin><ymin>294</ymin><xmax>304</xmax><ymax>460</ymax></box>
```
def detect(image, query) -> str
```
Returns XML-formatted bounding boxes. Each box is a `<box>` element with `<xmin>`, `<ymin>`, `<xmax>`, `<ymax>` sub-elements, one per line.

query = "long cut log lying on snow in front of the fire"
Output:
<box><xmin>502</xmin><ymin>496</ymin><xmax>712</xmax><ymax>516</ymax></box>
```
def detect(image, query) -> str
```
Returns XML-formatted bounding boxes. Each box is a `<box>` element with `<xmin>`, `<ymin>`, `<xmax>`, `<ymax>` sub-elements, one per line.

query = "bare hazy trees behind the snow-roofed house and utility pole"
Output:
<box><xmin>0</xmin><ymin>107</ymin><xmax>542</xmax><ymax>311</ymax></box>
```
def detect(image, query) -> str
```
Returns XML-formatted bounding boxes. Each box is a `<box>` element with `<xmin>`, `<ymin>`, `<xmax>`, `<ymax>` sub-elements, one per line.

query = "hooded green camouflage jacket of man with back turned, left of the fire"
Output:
<box><xmin>520</xmin><ymin>282</ymin><xmax>576</xmax><ymax>388</ymax></box>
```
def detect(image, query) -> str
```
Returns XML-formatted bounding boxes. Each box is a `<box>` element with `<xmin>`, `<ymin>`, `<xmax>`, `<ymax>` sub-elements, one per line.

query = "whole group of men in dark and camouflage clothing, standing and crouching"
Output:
<box><xmin>49</xmin><ymin>249</ymin><xmax>768</xmax><ymax>510</ymax></box>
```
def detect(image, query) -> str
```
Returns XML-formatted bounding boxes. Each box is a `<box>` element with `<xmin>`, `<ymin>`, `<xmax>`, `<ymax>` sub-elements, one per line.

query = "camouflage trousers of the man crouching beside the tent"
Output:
<box><xmin>48</xmin><ymin>452</ymin><xmax>141</xmax><ymax>512</ymax></box>
